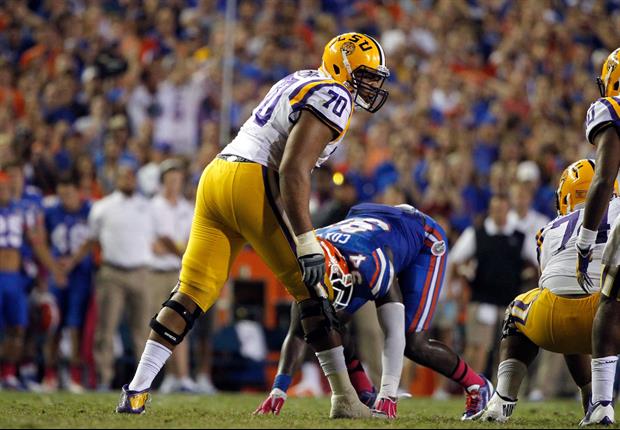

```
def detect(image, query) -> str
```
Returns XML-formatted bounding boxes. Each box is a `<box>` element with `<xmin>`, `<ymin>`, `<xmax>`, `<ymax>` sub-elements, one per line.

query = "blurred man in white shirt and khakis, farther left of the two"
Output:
<box><xmin>88</xmin><ymin>163</ymin><xmax>155</xmax><ymax>390</ymax></box>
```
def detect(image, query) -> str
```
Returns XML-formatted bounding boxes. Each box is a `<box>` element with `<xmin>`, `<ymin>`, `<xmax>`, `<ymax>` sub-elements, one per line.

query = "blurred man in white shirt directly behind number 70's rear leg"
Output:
<box><xmin>149</xmin><ymin>159</ymin><xmax>196</xmax><ymax>393</ymax></box>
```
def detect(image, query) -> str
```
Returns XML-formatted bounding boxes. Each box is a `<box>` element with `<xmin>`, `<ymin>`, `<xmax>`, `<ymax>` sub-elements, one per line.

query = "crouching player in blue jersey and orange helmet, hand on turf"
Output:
<box><xmin>255</xmin><ymin>203</ymin><xmax>493</xmax><ymax>420</ymax></box>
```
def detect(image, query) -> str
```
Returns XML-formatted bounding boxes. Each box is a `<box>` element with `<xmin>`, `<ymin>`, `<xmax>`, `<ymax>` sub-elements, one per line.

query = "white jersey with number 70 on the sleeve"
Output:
<box><xmin>222</xmin><ymin>70</ymin><xmax>353</xmax><ymax>171</ymax></box>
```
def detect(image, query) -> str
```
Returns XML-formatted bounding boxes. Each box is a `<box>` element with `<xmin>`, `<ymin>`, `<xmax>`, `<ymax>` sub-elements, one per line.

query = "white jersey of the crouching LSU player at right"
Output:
<box><xmin>538</xmin><ymin>198</ymin><xmax>620</xmax><ymax>294</ymax></box>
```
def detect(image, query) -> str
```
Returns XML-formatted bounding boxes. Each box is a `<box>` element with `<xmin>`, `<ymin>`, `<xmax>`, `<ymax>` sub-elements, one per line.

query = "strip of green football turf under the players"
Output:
<box><xmin>0</xmin><ymin>392</ymin><xmax>582</xmax><ymax>429</ymax></box>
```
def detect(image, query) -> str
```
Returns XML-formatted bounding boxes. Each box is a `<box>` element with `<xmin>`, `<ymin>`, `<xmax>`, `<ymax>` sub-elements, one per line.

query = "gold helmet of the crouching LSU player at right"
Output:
<box><xmin>555</xmin><ymin>159</ymin><xmax>618</xmax><ymax>215</ymax></box>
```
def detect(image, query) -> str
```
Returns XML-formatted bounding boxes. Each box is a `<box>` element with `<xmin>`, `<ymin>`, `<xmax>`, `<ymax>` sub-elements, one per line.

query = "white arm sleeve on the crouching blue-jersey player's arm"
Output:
<box><xmin>377</xmin><ymin>302</ymin><xmax>406</xmax><ymax>397</ymax></box>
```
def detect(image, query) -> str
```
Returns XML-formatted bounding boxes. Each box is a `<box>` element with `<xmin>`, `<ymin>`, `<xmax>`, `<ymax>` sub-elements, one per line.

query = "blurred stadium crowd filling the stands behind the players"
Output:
<box><xmin>0</xmin><ymin>0</ymin><xmax>620</xmax><ymax>396</ymax></box>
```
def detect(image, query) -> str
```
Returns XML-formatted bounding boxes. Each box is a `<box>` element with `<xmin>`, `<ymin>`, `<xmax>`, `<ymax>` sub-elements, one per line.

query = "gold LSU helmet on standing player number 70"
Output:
<box><xmin>321</xmin><ymin>33</ymin><xmax>390</xmax><ymax>113</ymax></box>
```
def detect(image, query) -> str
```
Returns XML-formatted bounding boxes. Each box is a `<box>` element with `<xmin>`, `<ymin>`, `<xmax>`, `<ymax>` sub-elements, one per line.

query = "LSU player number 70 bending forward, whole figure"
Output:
<box><xmin>117</xmin><ymin>33</ymin><xmax>389</xmax><ymax>418</ymax></box>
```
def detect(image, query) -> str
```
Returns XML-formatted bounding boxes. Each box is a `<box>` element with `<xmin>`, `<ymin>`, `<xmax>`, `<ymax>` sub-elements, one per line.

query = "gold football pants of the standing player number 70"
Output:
<box><xmin>178</xmin><ymin>158</ymin><xmax>310</xmax><ymax>311</ymax></box>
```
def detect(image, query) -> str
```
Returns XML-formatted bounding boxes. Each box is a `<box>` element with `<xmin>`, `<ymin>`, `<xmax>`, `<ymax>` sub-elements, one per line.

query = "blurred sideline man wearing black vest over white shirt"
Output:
<box><xmin>449</xmin><ymin>194</ymin><xmax>537</xmax><ymax>373</ymax></box>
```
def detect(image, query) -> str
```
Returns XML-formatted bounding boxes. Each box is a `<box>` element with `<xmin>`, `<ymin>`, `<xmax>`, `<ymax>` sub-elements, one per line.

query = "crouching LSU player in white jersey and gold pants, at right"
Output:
<box><xmin>472</xmin><ymin>160</ymin><xmax>620</xmax><ymax>422</ymax></box>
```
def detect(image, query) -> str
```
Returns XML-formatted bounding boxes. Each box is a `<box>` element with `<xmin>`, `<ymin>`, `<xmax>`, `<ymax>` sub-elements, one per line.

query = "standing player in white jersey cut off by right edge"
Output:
<box><xmin>576</xmin><ymin>48</ymin><xmax>620</xmax><ymax>426</ymax></box>
